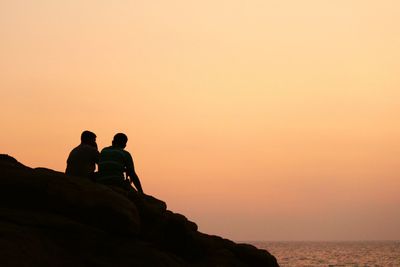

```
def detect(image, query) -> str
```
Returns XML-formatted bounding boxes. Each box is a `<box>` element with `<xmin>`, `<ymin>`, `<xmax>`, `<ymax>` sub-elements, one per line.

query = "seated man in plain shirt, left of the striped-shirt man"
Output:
<box><xmin>65</xmin><ymin>131</ymin><xmax>99</xmax><ymax>178</ymax></box>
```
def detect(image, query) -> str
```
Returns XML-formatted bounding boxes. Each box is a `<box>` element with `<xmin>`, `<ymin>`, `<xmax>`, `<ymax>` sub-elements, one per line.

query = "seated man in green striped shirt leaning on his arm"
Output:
<box><xmin>97</xmin><ymin>133</ymin><xmax>143</xmax><ymax>194</ymax></box>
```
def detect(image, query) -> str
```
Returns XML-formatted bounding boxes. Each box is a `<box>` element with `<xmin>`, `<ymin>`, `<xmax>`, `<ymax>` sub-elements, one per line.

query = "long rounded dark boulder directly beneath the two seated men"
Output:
<box><xmin>0</xmin><ymin>157</ymin><xmax>140</xmax><ymax>237</ymax></box>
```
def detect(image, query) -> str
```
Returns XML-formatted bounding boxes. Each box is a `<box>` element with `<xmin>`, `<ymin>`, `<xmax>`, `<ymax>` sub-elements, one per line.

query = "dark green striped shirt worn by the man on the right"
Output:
<box><xmin>98</xmin><ymin>146</ymin><xmax>134</xmax><ymax>182</ymax></box>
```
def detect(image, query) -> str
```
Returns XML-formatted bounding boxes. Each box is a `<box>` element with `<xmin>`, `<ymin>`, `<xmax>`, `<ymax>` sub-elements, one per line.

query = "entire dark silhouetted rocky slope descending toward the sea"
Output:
<box><xmin>0</xmin><ymin>155</ymin><xmax>278</xmax><ymax>266</ymax></box>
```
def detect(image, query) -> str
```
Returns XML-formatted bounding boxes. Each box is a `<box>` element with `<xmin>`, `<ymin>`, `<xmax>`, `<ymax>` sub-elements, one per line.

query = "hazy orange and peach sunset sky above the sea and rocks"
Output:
<box><xmin>0</xmin><ymin>0</ymin><xmax>400</xmax><ymax>241</ymax></box>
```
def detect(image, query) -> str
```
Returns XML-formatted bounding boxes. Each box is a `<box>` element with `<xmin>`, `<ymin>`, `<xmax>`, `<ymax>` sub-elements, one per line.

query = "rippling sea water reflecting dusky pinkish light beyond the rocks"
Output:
<box><xmin>250</xmin><ymin>241</ymin><xmax>400</xmax><ymax>267</ymax></box>
